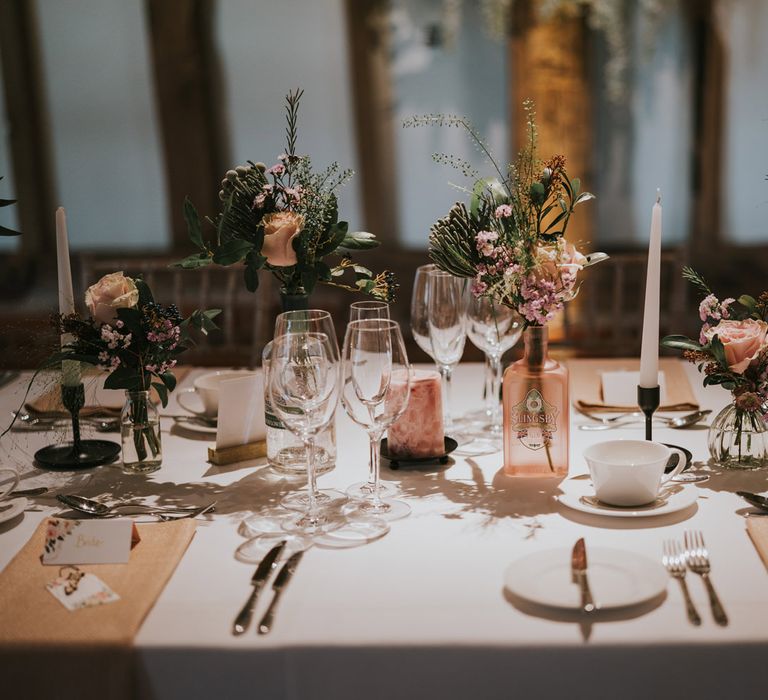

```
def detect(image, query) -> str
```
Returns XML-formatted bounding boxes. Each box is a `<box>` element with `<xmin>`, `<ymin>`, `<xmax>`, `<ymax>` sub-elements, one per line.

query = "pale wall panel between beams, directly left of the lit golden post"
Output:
<box><xmin>392</xmin><ymin>0</ymin><xmax>509</xmax><ymax>248</ymax></box>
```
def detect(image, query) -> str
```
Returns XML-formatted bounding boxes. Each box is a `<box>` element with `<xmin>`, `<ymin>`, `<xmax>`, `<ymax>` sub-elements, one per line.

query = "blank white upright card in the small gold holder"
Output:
<box><xmin>216</xmin><ymin>372</ymin><xmax>267</xmax><ymax>451</ymax></box>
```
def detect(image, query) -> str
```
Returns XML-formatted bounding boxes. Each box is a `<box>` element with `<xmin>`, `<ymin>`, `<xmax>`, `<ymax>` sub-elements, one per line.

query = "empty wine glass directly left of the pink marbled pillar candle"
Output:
<box><xmin>341</xmin><ymin>319</ymin><xmax>411</xmax><ymax>520</ymax></box>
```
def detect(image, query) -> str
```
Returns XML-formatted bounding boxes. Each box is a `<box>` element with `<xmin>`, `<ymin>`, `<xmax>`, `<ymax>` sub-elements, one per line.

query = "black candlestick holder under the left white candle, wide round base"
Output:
<box><xmin>35</xmin><ymin>384</ymin><xmax>120</xmax><ymax>469</ymax></box>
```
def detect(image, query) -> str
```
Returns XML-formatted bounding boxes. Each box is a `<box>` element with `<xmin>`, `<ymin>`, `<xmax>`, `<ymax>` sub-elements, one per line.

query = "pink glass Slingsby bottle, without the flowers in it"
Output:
<box><xmin>503</xmin><ymin>326</ymin><xmax>570</xmax><ymax>476</ymax></box>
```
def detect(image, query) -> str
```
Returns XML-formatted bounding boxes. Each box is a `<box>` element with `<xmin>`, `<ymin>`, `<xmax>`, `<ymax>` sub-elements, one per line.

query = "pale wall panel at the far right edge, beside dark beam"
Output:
<box><xmin>719</xmin><ymin>0</ymin><xmax>768</xmax><ymax>244</ymax></box>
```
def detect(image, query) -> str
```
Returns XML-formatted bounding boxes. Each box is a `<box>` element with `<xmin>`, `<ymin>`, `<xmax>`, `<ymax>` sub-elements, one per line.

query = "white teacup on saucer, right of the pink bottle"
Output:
<box><xmin>584</xmin><ymin>440</ymin><xmax>685</xmax><ymax>506</ymax></box>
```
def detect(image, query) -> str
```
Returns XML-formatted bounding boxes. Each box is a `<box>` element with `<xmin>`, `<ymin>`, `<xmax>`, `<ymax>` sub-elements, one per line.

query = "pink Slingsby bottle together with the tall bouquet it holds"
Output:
<box><xmin>412</xmin><ymin>102</ymin><xmax>607</xmax><ymax>476</ymax></box>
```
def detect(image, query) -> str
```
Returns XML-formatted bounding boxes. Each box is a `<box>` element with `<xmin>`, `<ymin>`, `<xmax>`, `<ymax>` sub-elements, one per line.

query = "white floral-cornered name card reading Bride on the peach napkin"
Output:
<box><xmin>42</xmin><ymin>518</ymin><xmax>138</xmax><ymax>566</ymax></box>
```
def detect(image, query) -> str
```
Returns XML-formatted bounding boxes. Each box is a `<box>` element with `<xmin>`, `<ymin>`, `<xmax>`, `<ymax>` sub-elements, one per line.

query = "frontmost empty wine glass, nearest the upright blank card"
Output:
<box><xmin>268</xmin><ymin>332</ymin><xmax>341</xmax><ymax>535</ymax></box>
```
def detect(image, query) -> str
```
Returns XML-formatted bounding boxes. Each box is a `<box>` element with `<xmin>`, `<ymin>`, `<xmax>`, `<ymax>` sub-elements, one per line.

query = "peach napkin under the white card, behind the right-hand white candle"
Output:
<box><xmin>567</xmin><ymin>357</ymin><xmax>699</xmax><ymax>413</ymax></box>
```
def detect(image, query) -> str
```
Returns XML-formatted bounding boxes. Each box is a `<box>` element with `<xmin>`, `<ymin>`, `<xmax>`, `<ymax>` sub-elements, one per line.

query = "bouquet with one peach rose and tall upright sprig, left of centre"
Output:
<box><xmin>176</xmin><ymin>90</ymin><xmax>397</xmax><ymax>301</ymax></box>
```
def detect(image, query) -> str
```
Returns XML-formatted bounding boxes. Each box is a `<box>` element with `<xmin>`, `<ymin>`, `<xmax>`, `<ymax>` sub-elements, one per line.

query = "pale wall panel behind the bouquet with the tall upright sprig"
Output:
<box><xmin>216</xmin><ymin>0</ymin><xmax>363</xmax><ymax>230</ymax></box>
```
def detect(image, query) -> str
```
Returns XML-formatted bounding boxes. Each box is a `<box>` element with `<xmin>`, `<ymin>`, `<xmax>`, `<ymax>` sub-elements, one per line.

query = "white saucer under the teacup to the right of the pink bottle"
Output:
<box><xmin>555</xmin><ymin>479</ymin><xmax>699</xmax><ymax>518</ymax></box>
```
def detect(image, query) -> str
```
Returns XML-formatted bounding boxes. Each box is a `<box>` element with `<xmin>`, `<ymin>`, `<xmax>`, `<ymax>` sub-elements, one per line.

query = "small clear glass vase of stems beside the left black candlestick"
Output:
<box><xmin>120</xmin><ymin>391</ymin><xmax>163</xmax><ymax>474</ymax></box>
